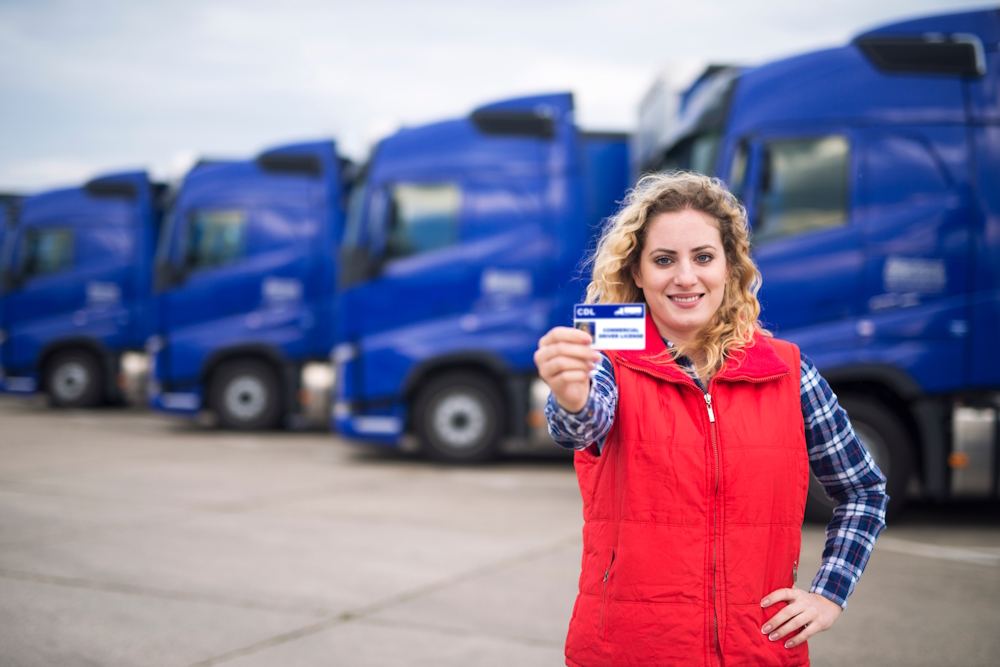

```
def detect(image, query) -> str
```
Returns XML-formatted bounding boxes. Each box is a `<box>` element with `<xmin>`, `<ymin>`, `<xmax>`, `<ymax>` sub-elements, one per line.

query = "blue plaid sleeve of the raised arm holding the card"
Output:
<box><xmin>545</xmin><ymin>354</ymin><xmax>618</xmax><ymax>452</ymax></box>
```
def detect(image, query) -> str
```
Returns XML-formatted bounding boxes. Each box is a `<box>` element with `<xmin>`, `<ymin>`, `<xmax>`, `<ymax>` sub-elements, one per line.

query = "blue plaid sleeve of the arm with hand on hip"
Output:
<box><xmin>801</xmin><ymin>354</ymin><xmax>889</xmax><ymax>607</ymax></box>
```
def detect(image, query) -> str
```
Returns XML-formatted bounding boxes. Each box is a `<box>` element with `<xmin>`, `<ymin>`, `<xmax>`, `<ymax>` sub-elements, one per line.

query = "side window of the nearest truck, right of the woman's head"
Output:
<box><xmin>754</xmin><ymin>136</ymin><xmax>850</xmax><ymax>242</ymax></box>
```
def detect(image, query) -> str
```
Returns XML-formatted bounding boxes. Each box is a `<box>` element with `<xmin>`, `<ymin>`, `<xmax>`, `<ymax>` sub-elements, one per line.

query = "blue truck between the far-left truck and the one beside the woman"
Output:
<box><xmin>147</xmin><ymin>141</ymin><xmax>351</xmax><ymax>429</ymax></box>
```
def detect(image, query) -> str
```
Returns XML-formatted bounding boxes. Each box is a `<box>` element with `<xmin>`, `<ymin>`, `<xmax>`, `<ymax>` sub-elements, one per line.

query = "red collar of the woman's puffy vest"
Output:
<box><xmin>615</xmin><ymin>314</ymin><xmax>790</xmax><ymax>386</ymax></box>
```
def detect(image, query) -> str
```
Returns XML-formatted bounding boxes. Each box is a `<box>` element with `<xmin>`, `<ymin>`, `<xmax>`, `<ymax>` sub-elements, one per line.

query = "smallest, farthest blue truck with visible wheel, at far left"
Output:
<box><xmin>0</xmin><ymin>172</ymin><xmax>164</xmax><ymax>407</ymax></box>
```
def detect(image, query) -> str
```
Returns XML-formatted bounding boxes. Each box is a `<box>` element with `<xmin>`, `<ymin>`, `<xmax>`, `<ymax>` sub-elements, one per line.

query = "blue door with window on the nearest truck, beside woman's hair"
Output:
<box><xmin>729</xmin><ymin>127</ymin><xmax>863</xmax><ymax>344</ymax></box>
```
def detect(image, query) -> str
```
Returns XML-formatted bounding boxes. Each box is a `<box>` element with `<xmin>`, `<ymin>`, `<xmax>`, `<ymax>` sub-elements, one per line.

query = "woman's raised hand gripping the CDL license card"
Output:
<box><xmin>535</xmin><ymin>327</ymin><xmax>601</xmax><ymax>413</ymax></box>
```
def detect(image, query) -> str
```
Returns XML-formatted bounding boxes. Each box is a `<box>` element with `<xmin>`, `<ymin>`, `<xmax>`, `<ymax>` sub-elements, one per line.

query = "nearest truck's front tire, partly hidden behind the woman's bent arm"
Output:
<box><xmin>806</xmin><ymin>395</ymin><xmax>913</xmax><ymax>523</ymax></box>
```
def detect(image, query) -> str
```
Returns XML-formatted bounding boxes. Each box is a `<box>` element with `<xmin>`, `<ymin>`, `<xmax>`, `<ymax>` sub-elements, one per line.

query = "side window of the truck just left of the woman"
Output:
<box><xmin>385</xmin><ymin>184</ymin><xmax>461</xmax><ymax>259</ymax></box>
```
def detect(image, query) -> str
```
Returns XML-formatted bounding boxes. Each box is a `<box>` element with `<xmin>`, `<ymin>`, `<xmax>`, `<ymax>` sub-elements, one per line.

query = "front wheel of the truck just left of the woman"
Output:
<box><xmin>413</xmin><ymin>371</ymin><xmax>503</xmax><ymax>463</ymax></box>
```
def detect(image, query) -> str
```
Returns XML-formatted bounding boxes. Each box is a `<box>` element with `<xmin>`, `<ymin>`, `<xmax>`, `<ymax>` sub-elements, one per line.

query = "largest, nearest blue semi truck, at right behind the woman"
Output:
<box><xmin>637</xmin><ymin>10</ymin><xmax>1000</xmax><ymax>519</ymax></box>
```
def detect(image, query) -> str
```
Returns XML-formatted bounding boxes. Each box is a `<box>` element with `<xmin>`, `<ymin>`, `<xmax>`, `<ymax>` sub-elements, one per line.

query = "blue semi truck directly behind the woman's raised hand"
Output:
<box><xmin>332</xmin><ymin>94</ymin><xmax>628</xmax><ymax>461</ymax></box>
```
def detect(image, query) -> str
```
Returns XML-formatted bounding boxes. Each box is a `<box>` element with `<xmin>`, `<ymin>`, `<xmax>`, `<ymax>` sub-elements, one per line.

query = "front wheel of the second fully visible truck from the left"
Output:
<box><xmin>209</xmin><ymin>359</ymin><xmax>282</xmax><ymax>431</ymax></box>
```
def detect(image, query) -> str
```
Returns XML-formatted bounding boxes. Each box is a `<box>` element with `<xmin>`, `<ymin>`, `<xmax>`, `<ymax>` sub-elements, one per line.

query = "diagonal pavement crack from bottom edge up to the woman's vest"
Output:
<box><xmin>190</xmin><ymin>532</ymin><xmax>580</xmax><ymax>667</ymax></box>
